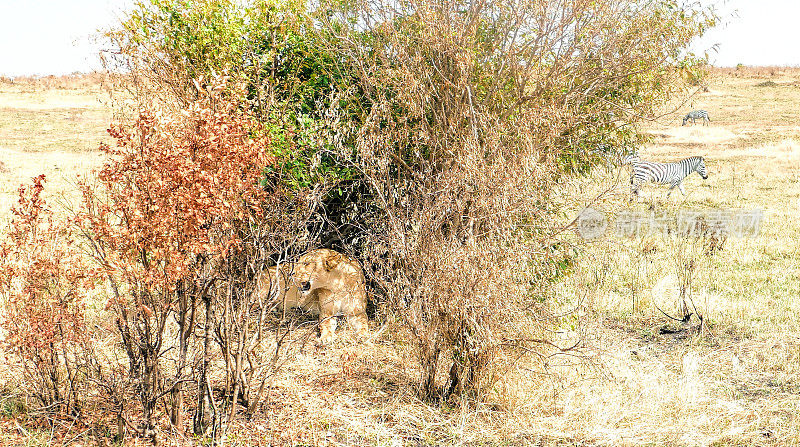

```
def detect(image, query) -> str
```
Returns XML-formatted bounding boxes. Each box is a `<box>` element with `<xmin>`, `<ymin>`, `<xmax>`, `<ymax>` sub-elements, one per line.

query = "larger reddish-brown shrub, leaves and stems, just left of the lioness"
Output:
<box><xmin>72</xmin><ymin>87</ymin><xmax>324</xmax><ymax>439</ymax></box>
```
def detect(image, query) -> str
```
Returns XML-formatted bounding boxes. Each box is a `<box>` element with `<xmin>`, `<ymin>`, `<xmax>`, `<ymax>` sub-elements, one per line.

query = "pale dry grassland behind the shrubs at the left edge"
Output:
<box><xmin>0</xmin><ymin>76</ymin><xmax>112</xmax><ymax>222</ymax></box>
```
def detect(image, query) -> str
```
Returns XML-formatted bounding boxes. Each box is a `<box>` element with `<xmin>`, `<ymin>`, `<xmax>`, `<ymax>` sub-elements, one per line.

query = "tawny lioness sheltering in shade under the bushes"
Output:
<box><xmin>255</xmin><ymin>248</ymin><xmax>369</xmax><ymax>345</ymax></box>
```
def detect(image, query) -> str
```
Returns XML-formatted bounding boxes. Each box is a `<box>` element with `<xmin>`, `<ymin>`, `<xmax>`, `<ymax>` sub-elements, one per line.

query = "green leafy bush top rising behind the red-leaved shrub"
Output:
<box><xmin>109</xmin><ymin>0</ymin><xmax>360</xmax><ymax>194</ymax></box>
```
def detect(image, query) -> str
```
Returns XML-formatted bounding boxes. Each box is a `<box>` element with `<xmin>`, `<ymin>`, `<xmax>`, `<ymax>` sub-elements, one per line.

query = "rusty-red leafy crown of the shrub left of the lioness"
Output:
<box><xmin>80</xmin><ymin>95</ymin><xmax>273</xmax><ymax>291</ymax></box>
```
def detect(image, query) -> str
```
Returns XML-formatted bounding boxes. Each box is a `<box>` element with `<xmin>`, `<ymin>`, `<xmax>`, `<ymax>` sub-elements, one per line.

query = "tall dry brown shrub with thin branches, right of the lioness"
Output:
<box><xmin>318</xmin><ymin>0</ymin><xmax>706</xmax><ymax>402</ymax></box>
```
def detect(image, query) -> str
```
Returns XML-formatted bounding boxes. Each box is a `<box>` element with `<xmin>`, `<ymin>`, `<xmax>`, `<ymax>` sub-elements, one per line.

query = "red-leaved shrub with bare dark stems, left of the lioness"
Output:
<box><xmin>76</xmin><ymin>89</ymin><xmax>296</xmax><ymax>435</ymax></box>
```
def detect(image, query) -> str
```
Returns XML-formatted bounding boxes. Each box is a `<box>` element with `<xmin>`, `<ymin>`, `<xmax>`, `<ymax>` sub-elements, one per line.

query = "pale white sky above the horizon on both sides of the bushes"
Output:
<box><xmin>0</xmin><ymin>0</ymin><xmax>800</xmax><ymax>76</ymax></box>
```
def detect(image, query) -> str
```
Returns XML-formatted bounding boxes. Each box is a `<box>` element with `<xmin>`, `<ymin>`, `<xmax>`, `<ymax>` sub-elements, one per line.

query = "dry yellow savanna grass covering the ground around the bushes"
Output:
<box><xmin>0</xmin><ymin>67</ymin><xmax>800</xmax><ymax>446</ymax></box>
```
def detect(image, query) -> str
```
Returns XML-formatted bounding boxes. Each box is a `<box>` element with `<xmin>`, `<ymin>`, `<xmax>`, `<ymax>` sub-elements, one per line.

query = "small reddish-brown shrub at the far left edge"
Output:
<box><xmin>0</xmin><ymin>175</ymin><xmax>93</xmax><ymax>410</ymax></box>
